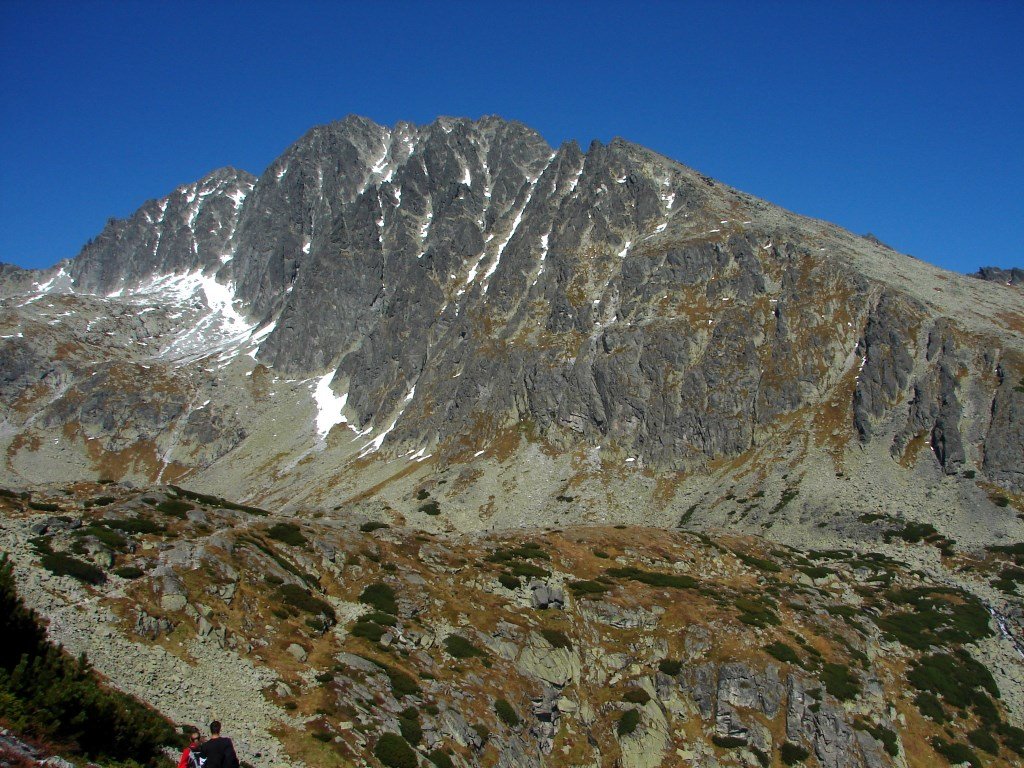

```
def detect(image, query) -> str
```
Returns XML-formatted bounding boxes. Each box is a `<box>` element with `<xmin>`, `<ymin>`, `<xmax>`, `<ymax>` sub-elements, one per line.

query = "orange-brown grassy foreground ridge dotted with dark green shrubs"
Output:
<box><xmin>0</xmin><ymin>484</ymin><xmax>1024</xmax><ymax>768</ymax></box>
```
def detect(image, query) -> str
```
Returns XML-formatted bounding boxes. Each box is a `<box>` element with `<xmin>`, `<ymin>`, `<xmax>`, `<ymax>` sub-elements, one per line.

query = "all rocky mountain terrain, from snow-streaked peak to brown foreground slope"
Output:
<box><xmin>0</xmin><ymin>117</ymin><xmax>1024</xmax><ymax>768</ymax></box>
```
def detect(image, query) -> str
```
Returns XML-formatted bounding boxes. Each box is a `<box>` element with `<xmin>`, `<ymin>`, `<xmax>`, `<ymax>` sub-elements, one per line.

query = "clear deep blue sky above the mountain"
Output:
<box><xmin>0</xmin><ymin>0</ymin><xmax>1024</xmax><ymax>271</ymax></box>
